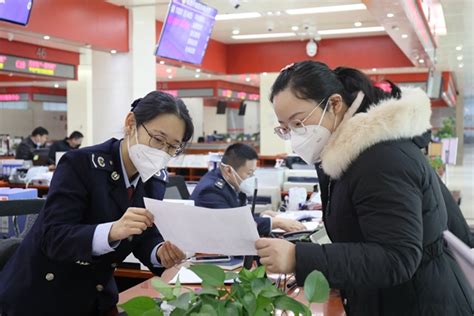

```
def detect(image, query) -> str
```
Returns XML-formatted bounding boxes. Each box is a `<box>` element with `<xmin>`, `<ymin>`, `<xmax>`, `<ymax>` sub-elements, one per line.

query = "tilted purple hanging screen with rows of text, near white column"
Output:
<box><xmin>156</xmin><ymin>0</ymin><xmax>217</xmax><ymax>65</ymax></box>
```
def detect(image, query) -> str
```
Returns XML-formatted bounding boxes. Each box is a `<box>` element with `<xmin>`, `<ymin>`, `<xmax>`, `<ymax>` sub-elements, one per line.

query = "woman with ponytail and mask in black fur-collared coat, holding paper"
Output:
<box><xmin>256</xmin><ymin>61</ymin><xmax>473</xmax><ymax>316</ymax></box>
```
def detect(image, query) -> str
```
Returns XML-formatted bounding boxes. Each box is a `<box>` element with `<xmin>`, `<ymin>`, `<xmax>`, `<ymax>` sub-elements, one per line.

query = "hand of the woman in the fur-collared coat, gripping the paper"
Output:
<box><xmin>255</xmin><ymin>238</ymin><xmax>296</xmax><ymax>273</ymax></box>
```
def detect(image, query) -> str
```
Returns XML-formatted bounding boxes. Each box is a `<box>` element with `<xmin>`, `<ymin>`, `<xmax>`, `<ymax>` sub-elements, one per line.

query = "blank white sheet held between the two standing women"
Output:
<box><xmin>144</xmin><ymin>198</ymin><xmax>259</xmax><ymax>256</ymax></box>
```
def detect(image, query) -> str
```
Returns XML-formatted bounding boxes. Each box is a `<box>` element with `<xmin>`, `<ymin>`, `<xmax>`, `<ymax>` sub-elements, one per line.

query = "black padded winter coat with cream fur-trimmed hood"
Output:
<box><xmin>296</xmin><ymin>89</ymin><xmax>473</xmax><ymax>316</ymax></box>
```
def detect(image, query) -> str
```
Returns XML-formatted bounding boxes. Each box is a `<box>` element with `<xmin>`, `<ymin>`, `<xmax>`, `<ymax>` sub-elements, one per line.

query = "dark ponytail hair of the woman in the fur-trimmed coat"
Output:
<box><xmin>270</xmin><ymin>60</ymin><xmax>401</xmax><ymax>113</ymax></box>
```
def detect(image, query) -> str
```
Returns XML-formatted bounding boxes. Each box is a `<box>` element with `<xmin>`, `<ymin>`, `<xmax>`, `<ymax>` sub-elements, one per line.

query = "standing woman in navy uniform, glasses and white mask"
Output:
<box><xmin>0</xmin><ymin>91</ymin><xmax>194</xmax><ymax>316</ymax></box>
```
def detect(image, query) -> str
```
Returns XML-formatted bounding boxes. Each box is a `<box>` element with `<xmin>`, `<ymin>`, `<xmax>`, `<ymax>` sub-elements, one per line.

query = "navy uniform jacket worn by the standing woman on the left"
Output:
<box><xmin>0</xmin><ymin>139</ymin><xmax>166</xmax><ymax>316</ymax></box>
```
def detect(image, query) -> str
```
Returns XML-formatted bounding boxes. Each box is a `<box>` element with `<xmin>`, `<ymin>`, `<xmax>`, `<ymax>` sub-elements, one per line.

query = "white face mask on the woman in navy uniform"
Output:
<box><xmin>128</xmin><ymin>129</ymin><xmax>171</xmax><ymax>182</ymax></box>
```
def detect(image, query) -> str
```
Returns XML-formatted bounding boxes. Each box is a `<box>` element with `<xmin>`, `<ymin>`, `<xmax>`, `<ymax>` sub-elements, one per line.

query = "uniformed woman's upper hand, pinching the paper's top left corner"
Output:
<box><xmin>109</xmin><ymin>207</ymin><xmax>154</xmax><ymax>243</ymax></box>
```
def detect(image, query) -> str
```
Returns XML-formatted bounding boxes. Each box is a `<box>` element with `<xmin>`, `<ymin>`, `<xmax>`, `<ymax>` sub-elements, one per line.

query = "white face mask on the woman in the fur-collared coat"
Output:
<box><xmin>290</xmin><ymin>100</ymin><xmax>336</xmax><ymax>165</ymax></box>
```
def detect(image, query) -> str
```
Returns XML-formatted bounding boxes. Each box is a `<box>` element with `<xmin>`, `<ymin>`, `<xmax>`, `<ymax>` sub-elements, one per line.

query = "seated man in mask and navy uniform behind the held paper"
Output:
<box><xmin>191</xmin><ymin>143</ymin><xmax>306</xmax><ymax>236</ymax></box>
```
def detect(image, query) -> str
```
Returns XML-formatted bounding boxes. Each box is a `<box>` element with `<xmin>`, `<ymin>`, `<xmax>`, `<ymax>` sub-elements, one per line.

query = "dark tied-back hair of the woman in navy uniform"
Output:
<box><xmin>131</xmin><ymin>91</ymin><xmax>194</xmax><ymax>144</ymax></box>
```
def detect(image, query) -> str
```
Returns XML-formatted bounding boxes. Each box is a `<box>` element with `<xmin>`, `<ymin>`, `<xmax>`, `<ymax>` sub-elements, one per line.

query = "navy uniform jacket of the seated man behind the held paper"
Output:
<box><xmin>191</xmin><ymin>169</ymin><xmax>272</xmax><ymax>236</ymax></box>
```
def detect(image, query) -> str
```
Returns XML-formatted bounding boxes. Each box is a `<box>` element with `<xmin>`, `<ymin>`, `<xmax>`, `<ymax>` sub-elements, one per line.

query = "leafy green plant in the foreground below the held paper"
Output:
<box><xmin>120</xmin><ymin>264</ymin><xmax>330</xmax><ymax>316</ymax></box>
